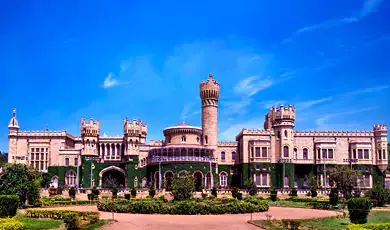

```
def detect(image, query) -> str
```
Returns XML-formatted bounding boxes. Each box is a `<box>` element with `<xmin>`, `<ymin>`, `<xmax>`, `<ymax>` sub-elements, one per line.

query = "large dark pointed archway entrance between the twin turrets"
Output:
<box><xmin>99</xmin><ymin>166</ymin><xmax>127</xmax><ymax>188</ymax></box>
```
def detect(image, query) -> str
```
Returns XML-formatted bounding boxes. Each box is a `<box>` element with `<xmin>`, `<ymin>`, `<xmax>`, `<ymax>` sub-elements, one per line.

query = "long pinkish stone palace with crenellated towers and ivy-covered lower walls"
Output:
<box><xmin>8</xmin><ymin>74</ymin><xmax>390</xmax><ymax>190</ymax></box>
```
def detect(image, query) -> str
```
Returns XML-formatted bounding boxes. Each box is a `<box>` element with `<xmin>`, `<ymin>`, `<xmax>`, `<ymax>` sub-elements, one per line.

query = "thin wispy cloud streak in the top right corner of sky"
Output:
<box><xmin>282</xmin><ymin>0</ymin><xmax>383</xmax><ymax>44</ymax></box>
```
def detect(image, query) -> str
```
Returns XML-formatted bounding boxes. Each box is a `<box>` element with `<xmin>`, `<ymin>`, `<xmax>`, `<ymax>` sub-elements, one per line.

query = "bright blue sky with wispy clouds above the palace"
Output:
<box><xmin>0</xmin><ymin>0</ymin><xmax>390</xmax><ymax>151</ymax></box>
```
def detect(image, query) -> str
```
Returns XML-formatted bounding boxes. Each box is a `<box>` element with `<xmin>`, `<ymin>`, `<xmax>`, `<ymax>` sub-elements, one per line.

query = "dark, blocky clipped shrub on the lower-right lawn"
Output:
<box><xmin>348</xmin><ymin>198</ymin><xmax>372</xmax><ymax>224</ymax></box>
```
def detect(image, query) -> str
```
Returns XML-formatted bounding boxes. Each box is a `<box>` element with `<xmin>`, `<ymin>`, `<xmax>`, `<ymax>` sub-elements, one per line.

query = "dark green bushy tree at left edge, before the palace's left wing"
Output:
<box><xmin>0</xmin><ymin>164</ymin><xmax>42</xmax><ymax>205</ymax></box>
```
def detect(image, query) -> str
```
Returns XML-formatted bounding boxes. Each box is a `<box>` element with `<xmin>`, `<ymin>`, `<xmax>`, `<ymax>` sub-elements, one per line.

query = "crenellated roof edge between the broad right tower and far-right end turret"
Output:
<box><xmin>294</xmin><ymin>130</ymin><xmax>374</xmax><ymax>137</ymax></box>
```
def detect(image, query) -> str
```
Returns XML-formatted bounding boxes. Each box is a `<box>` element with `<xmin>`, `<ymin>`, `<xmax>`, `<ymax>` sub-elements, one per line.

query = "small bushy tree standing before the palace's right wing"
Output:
<box><xmin>327</xmin><ymin>165</ymin><xmax>360</xmax><ymax>199</ymax></box>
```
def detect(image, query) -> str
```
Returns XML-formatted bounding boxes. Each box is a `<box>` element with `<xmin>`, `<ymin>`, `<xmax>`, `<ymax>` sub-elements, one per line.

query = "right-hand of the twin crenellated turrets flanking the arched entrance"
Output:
<box><xmin>123</xmin><ymin>118</ymin><xmax>148</xmax><ymax>156</ymax></box>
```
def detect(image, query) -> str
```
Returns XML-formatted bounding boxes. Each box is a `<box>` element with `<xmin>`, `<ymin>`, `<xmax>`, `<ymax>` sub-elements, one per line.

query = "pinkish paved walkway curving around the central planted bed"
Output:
<box><xmin>38</xmin><ymin>206</ymin><xmax>337</xmax><ymax>230</ymax></box>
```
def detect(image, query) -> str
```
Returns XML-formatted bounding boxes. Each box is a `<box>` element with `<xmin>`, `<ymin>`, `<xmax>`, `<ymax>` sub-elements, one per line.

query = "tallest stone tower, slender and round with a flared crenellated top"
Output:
<box><xmin>200</xmin><ymin>73</ymin><xmax>220</xmax><ymax>148</ymax></box>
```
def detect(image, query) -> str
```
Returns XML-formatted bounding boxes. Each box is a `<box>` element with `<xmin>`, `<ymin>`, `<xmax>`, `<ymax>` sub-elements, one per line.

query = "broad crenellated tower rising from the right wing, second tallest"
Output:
<box><xmin>268</xmin><ymin>104</ymin><xmax>295</xmax><ymax>159</ymax></box>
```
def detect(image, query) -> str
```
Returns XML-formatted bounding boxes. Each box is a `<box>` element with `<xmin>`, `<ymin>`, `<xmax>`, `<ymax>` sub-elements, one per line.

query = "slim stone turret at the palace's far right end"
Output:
<box><xmin>373</xmin><ymin>125</ymin><xmax>388</xmax><ymax>171</ymax></box>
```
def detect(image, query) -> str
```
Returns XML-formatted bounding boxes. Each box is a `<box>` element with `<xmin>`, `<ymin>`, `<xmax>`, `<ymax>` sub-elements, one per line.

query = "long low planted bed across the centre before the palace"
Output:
<box><xmin>97</xmin><ymin>199</ymin><xmax>269</xmax><ymax>215</ymax></box>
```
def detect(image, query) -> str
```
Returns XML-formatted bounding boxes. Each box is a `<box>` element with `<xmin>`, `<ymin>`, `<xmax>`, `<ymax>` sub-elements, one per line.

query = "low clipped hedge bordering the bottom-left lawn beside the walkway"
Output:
<box><xmin>26</xmin><ymin>209</ymin><xmax>99</xmax><ymax>224</ymax></box>
